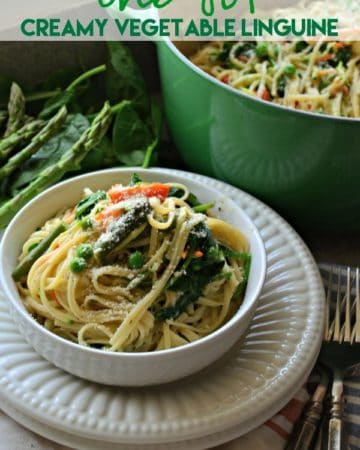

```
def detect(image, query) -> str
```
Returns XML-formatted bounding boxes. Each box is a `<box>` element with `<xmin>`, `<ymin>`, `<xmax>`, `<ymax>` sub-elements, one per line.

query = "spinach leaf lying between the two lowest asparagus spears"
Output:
<box><xmin>10</xmin><ymin>114</ymin><xmax>89</xmax><ymax>195</ymax></box>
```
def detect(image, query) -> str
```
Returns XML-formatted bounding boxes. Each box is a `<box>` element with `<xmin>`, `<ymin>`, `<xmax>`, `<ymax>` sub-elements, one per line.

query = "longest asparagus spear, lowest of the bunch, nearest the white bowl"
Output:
<box><xmin>0</xmin><ymin>102</ymin><xmax>112</xmax><ymax>228</ymax></box>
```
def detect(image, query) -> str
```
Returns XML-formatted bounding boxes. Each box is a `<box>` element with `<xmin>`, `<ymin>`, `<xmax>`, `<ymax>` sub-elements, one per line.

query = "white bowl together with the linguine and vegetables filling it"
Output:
<box><xmin>1</xmin><ymin>170</ymin><xmax>265</xmax><ymax>385</ymax></box>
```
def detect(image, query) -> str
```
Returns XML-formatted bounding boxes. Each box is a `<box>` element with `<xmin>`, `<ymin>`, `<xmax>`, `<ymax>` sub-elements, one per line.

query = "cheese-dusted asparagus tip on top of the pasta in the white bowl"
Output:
<box><xmin>94</xmin><ymin>198</ymin><xmax>151</xmax><ymax>263</ymax></box>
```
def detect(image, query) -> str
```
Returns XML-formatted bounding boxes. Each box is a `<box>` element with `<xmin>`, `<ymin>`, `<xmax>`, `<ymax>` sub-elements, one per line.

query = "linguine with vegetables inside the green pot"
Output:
<box><xmin>190</xmin><ymin>0</ymin><xmax>360</xmax><ymax>118</ymax></box>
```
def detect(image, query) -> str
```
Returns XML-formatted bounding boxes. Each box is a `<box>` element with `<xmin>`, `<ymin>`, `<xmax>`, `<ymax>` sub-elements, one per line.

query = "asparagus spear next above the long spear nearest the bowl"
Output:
<box><xmin>0</xmin><ymin>106</ymin><xmax>67</xmax><ymax>179</ymax></box>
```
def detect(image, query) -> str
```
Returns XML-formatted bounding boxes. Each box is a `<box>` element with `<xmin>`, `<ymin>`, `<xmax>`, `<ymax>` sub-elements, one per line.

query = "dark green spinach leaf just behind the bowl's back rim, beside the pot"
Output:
<box><xmin>113</xmin><ymin>101</ymin><xmax>153</xmax><ymax>166</ymax></box>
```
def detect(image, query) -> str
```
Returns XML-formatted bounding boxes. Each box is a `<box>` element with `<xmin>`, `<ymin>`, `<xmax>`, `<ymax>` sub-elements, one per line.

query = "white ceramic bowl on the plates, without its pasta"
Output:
<box><xmin>0</xmin><ymin>168</ymin><xmax>266</xmax><ymax>386</ymax></box>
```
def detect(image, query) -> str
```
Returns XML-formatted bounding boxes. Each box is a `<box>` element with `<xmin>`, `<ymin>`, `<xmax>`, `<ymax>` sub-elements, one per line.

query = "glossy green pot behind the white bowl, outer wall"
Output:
<box><xmin>158</xmin><ymin>42</ymin><xmax>360</xmax><ymax>230</ymax></box>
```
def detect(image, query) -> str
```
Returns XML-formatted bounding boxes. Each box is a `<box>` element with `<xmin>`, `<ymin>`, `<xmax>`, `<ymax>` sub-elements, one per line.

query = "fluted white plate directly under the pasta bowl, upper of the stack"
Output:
<box><xmin>0</xmin><ymin>170</ymin><xmax>324</xmax><ymax>448</ymax></box>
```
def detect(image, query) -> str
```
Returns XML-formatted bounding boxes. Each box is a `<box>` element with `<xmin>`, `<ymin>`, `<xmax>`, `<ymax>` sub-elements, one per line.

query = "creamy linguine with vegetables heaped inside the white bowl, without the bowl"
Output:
<box><xmin>13</xmin><ymin>177</ymin><xmax>250</xmax><ymax>352</ymax></box>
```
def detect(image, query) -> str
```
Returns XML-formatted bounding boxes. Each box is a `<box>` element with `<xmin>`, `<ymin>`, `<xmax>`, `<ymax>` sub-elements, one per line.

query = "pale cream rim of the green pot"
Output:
<box><xmin>158</xmin><ymin>38</ymin><xmax>360</xmax><ymax>125</ymax></box>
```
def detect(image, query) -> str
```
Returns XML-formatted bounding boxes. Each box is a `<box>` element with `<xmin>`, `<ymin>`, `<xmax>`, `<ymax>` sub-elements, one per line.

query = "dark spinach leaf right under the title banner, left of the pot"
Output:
<box><xmin>105</xmin><ymin>42</ymin><xmax>150</xmax><ymax>113</ymax></box>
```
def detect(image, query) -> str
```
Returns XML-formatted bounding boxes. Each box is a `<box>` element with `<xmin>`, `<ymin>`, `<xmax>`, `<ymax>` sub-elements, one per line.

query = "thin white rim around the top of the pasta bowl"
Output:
<box><xmin>0</xmin><ymin>167</ymin><xmax>267</xmax><ymax>363</ymax></box>
